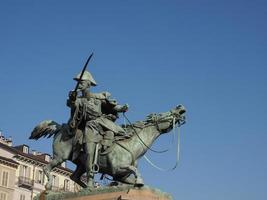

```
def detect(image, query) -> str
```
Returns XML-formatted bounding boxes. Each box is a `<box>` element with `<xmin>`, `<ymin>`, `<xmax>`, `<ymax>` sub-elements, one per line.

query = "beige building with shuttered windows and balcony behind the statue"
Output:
<box><xmin>0</xmin><ymin>135</ymin><xmax>80</xmax><ymax>200</ymax></box>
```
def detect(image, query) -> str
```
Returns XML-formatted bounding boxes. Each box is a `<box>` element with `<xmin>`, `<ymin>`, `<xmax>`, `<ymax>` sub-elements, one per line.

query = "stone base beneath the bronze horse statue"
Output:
<box><xmin>34</xmin><ymin>186</ymin><xmax>172</xmax><ymax>200</ymax></box>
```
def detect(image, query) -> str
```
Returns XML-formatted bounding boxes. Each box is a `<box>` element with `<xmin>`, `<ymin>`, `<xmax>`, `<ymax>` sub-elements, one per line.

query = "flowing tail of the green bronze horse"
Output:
<box><xmin>29</xmin><ymin>120</ymin><xmax>61</xmax><ymax>140</ymax></box>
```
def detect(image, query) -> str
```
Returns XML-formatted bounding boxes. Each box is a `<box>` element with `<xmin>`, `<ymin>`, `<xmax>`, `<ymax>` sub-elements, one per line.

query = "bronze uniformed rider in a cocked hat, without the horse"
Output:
<box><xmin>67</xmin><ymin>71</ymin><xmax>128</xmax><ymax>188</ymax></box>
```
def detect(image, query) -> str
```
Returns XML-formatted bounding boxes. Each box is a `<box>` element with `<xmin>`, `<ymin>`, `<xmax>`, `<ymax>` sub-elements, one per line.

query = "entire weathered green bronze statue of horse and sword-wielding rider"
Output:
<box><xmin>30</xmin><ymin>56</ymin><xmax>185</xmax><ymax>190</ymax></box>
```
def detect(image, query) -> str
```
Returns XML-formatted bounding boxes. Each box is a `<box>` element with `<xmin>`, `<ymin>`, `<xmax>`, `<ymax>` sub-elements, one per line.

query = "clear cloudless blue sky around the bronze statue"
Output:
<box><xmin>0</xmin><ymin>0</ymin><xmax>267</xmax><ymax>200</ymax></box>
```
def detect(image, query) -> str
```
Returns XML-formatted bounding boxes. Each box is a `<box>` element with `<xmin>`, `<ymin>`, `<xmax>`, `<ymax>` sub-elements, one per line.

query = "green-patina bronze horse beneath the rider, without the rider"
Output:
<box><xmin>30</xmin><ymin>105</ymin><xmax>186</xmax><ymax>190</ymax></box>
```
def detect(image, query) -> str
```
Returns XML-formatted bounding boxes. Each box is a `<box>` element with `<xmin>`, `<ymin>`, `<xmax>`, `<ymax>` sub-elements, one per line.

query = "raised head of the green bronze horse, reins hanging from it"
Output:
<box><xmin>147</xmin><ymin>105</ymin><xmax>186</xmax><ymax>133</ymax></box>
